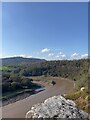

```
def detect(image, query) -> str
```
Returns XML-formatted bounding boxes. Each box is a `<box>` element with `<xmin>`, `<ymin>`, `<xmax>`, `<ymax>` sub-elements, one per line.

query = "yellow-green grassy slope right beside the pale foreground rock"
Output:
<box><xmin>65</xmin><ymin>88</ymin><xmax>90</xmax><ymax>113</ymax></box>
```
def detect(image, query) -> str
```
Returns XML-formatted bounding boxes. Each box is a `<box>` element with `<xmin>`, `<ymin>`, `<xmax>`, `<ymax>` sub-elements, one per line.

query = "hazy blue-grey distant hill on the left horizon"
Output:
<box><xmin>0</xmin><ymin>57</ymin><xmax>46</xmax><ymax>65</ymax></box>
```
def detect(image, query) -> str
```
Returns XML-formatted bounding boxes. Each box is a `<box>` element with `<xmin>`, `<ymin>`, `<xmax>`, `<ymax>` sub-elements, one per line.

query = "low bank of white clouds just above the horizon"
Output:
<box><xmin>3</xmin><ymin>48</ymin><xmax>88</xmax><ymax>60</ymax></box>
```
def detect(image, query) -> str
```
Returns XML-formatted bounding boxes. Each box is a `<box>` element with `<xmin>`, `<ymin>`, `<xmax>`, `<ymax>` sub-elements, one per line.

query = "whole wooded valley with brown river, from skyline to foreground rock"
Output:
<box><xmin>0</xmin><ymin>58</ymin><xmax>90</xmax><ymax>118</ymax></box>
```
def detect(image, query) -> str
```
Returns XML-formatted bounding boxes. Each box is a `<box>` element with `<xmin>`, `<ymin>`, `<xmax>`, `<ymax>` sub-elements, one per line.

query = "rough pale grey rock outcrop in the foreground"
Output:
<box><xmin>26</xmin><ymin>95</ymin><xmax>89</xmax><ymax>120</ymax></box>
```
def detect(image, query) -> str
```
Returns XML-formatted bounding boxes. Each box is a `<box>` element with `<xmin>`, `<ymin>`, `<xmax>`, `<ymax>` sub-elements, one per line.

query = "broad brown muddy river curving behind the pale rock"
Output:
<box><xmin>2</xmin><ymin>77</ymin><xmax>74</xmax><ymax>118</ymax></box>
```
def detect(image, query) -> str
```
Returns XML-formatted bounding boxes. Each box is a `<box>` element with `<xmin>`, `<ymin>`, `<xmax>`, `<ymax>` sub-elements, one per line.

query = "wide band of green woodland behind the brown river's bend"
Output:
<box><xmin>2</xmin><ymin>58</ymin><xmax>90</xmax><ymax>94</ymax></box>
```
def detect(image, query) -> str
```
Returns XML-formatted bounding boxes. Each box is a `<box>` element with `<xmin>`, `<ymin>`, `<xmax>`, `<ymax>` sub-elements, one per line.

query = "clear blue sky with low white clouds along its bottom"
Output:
<box><xmin>2</xmin><ymin>2</ymin><xmax>88</xmax><ymax>60</ymax></box>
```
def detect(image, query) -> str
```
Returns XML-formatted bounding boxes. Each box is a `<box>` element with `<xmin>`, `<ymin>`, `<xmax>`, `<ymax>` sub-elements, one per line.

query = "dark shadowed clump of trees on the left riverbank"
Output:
<box><xmin>2</xmin><ymin>74</ymin><xmax>38</xmax><ymax>93</ymax></box>
